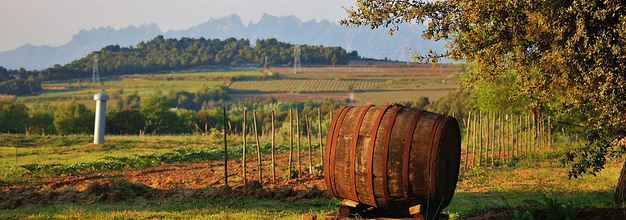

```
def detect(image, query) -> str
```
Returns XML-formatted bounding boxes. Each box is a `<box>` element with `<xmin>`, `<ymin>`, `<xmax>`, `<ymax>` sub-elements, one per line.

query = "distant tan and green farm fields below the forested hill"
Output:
<box><xmin>9</xmin><ymin>65</ymin><xmax>459</xmax><ymax>106</ymax></box>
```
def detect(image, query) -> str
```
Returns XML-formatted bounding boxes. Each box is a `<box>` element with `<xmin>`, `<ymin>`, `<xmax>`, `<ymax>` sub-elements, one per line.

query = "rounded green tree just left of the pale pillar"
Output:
<box><xmin>54</xmin><ymin>100</ymin><xmax>95</xmax><ymax>135</ymax></box>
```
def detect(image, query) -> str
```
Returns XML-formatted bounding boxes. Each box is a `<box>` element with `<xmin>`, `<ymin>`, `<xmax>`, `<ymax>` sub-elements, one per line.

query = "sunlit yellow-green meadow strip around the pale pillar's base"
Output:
<box><xmin>0</xmin><ymin>134</ymin><xmax>211</xmax><ymax>169</ymax></box>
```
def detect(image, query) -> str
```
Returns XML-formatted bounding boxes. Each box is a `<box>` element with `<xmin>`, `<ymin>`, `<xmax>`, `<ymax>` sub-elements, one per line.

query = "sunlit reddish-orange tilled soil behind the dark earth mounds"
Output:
<box><xmin>0</xmin><ymin>151</ymin><xmax>326</xmax><ymax>192</ymax></box>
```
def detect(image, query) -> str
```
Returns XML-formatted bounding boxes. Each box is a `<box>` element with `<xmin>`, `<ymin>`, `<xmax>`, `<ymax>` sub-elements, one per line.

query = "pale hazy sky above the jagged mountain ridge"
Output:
<box><xmin>0</xmin><ymin>0</ymin><xmax>353</xmax><ymax>51</ymax></box>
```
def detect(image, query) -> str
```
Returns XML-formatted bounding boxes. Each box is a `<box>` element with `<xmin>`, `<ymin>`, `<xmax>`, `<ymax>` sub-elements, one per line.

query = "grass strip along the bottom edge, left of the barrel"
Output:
<box><xmin>0</xmin><ymin>199</ymin><xmax>338</xmax><ymax>219</ymax></box>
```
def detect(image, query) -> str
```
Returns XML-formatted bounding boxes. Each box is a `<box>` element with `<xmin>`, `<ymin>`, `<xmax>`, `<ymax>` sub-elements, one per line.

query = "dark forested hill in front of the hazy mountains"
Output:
<box><xmin>38</xmin><ymin>35</ymin><xmax>359</xmax><ymax>80</ymax></box>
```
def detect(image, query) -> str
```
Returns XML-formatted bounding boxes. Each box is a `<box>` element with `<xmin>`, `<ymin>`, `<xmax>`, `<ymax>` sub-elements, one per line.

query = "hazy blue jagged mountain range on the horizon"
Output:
<box><xmin>0</xmin><ymin>14</ymin><xmax>444</xmax><ymax>70</ymax></box>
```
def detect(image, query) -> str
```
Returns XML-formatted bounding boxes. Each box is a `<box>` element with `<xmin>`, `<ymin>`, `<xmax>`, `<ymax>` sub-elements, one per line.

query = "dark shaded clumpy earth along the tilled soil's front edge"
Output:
<box><xmin>0</xmin><ymin>180</ymin><xmax>330</xmax><ymax>209</ymax></box>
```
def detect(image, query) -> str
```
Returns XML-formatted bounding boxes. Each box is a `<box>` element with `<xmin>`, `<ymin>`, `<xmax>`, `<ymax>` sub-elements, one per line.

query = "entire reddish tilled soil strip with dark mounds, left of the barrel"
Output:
<box><xmin>0</xmin><ymin>151</ymin><xmax>330</xmax><ymax>209</ymax></box>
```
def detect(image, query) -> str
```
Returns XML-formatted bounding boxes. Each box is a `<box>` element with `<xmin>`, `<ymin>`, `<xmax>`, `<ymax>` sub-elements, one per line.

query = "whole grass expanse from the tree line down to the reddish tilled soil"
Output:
<box><xmin>0</xmin><ymin>134</ymin><xmax>298</xmax><ymax>182</ymax></box>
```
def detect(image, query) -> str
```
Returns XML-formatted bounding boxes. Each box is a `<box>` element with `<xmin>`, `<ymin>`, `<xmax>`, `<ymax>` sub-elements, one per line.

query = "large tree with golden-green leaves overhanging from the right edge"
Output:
<box><xmin>342</xmin><ymin>0</ymin><xmax>626</xmax><ymax>203</ymax></box>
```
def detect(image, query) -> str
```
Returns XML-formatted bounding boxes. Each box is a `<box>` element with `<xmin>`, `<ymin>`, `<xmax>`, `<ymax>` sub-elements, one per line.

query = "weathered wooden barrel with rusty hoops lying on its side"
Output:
<box><xmin>324</xmin><ymin>105</ymin><xmax>461</xmax><ymax>211</ymax></box>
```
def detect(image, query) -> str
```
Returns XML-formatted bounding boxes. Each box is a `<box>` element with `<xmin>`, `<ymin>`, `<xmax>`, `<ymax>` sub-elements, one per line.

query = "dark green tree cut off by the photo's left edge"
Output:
<box><xmin>0</xmin><ymin>101</ymin><xmax>29</xmax><ymax>133</ymax></box>
